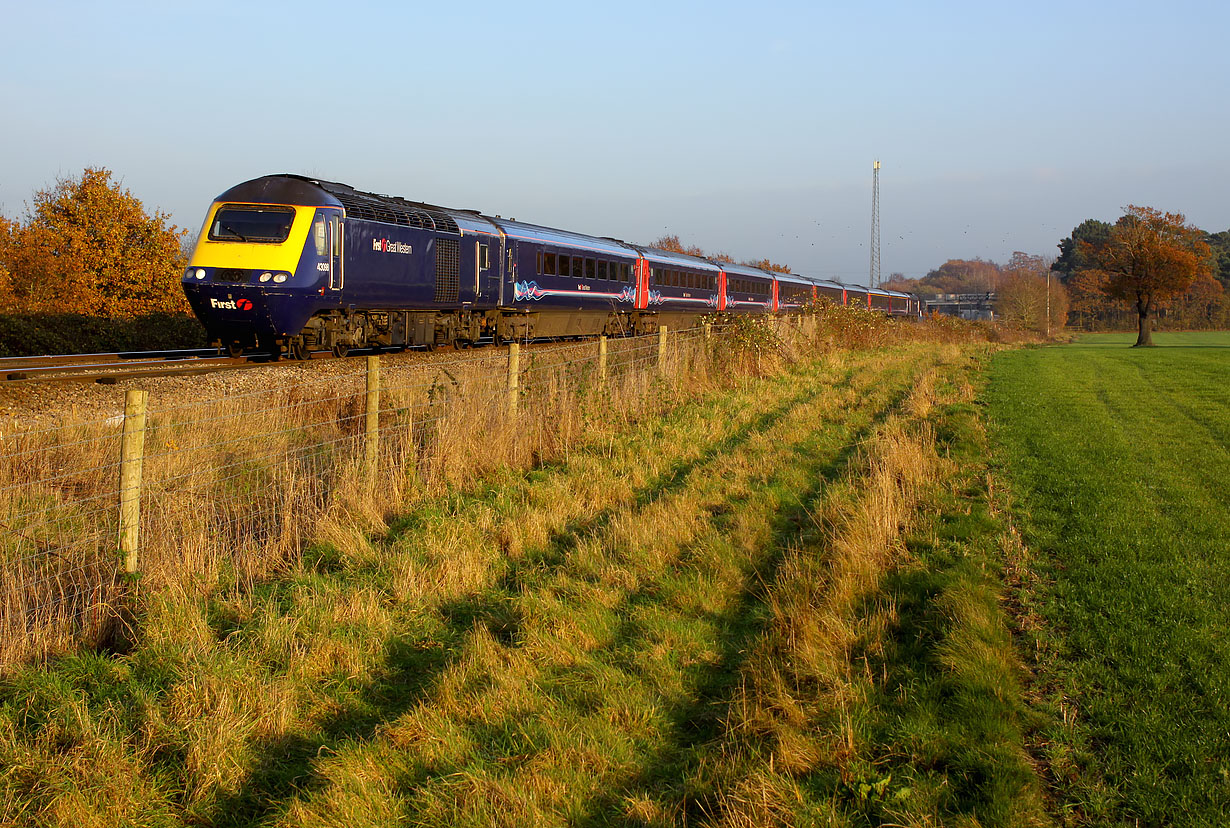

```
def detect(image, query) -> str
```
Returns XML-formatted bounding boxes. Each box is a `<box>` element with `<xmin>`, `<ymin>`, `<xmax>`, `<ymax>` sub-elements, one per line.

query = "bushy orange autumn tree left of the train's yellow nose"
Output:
<box><xmin>0</xmin><ymin>167</ymin><xmax>187</xmax><ymax>319</ymax></box>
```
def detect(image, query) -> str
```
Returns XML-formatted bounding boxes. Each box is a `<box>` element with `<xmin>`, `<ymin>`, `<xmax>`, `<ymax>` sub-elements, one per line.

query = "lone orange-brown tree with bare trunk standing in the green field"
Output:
<box><xmin>1079</xmin><ymin>210</ymin><xmax>1212</xmax><ymax>347</ymax></box>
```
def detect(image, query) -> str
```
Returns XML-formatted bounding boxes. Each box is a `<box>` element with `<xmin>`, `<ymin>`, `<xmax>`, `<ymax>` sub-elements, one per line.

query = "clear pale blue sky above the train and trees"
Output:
<box><xmin>0</xmin><ymin>0</ymin><xmax>1230</xmax><ymax>282</ymax></box>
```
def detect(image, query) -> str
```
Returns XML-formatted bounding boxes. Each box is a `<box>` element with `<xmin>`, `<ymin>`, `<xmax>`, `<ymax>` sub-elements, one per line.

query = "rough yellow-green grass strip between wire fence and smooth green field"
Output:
<box><xmin>0</xmin><ymin>344</ymin><xmax>1047</xmax><ymax>827</ymax></box>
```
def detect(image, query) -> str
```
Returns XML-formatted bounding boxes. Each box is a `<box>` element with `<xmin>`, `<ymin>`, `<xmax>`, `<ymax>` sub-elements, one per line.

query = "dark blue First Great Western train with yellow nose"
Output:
<box><xmin>183</xmin><ymin>173</ymin><xmax>920</xmax><ymax>358</ymax></box>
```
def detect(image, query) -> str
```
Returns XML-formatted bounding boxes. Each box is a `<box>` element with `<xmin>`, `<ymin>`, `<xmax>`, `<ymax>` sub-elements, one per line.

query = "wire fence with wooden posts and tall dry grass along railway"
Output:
<box><xmin>0</xmin><ymin>319</ymin><xmax>777</xmax><ymax>663</ymax></box>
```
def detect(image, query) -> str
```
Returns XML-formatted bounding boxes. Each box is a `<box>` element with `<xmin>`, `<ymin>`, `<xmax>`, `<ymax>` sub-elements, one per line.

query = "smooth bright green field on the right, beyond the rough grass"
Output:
<box><xmin>986</xmin><ymin>333</ymin><xmax>1230</xmax><ymax>826</ymax></box>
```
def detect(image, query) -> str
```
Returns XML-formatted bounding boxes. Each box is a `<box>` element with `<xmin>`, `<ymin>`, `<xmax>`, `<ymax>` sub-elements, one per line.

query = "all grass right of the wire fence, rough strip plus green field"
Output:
<box><xmin>26</xmin><ymin>314</ymin><xmax>1230</xmax><ymax>828</ymax></box>
